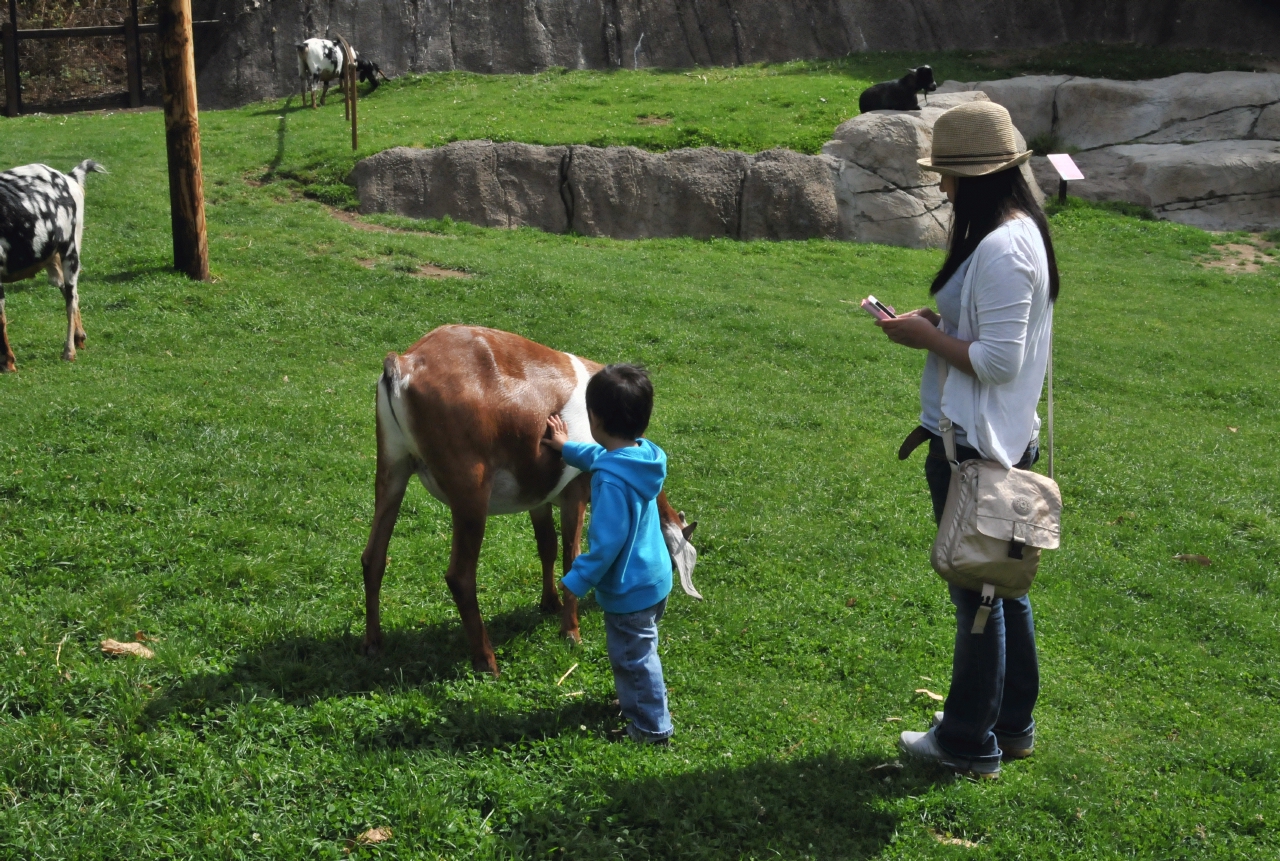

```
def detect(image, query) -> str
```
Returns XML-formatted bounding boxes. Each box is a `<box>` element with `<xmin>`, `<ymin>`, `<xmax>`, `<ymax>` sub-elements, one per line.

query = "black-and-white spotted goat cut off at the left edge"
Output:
<box><xmin>0</xmin><ymin>159</ymin><xmax>106</xmax><ymax>371</ymax></box>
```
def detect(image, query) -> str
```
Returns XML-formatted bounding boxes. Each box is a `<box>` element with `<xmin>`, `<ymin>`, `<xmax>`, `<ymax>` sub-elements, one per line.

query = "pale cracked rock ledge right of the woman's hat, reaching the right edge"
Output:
<box><xmin>938</xmin><ymin>72</ymin><xmax>1280</xmax><ymax>230</ymax></box>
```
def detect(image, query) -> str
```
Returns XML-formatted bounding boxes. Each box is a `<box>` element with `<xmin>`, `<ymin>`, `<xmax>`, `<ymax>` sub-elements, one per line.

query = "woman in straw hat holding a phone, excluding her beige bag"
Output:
<box><xmin>877</xmin><ymin>102</ymin><xmax>1057</xmax><ymax>778</ymax></box>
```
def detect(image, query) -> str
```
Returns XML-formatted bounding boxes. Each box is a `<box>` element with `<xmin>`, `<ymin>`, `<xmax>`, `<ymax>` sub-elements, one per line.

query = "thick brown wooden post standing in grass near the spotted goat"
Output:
<box><xmin>157</xmin><ymin>0</ymin><xmax>209</xmax><ymax>281</ymax></box>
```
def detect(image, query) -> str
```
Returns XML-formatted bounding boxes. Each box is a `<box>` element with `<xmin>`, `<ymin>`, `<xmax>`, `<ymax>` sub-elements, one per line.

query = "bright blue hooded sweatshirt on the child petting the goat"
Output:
<box><xmin>561</xmin><ymin>439</ymin><xmax>671</xmax><ymax>613</ymax></box>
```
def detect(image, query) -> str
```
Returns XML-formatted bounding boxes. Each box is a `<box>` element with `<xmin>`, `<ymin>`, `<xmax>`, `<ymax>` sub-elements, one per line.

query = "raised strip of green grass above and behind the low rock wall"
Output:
<box><xmin>236</xmin><ymin>45</ymin><xmax>1256</xmax><ymax>206</ymax></box>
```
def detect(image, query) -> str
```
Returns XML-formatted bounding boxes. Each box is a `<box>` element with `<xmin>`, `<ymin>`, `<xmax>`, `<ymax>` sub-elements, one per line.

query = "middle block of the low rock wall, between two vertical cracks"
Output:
<box><xmin>566</xmin><ymin>146</ymin><xmax>749</xmax><ymax>239</ymax></box>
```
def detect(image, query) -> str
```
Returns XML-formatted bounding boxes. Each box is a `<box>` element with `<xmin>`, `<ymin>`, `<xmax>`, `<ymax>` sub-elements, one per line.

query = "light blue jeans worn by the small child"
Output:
<box><xmin>604</xmin><ymin>599</ymin><xmax>676</xmax><ymax>742</ymax></box>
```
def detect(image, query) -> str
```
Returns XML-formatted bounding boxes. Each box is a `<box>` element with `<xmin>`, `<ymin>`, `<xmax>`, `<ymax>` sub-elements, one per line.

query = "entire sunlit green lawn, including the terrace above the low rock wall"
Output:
<box><xmin>0</xmin><ymin>48</ymin><xmax>1280</xmax><ymax>860</ymax></box>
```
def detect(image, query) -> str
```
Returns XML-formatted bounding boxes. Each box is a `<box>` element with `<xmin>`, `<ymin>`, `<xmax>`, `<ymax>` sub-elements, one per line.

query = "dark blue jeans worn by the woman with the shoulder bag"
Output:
<box><xmin>924</xmin><ymin>438</ymin><xmax>1039</xmax><ymax>760</ymax></box>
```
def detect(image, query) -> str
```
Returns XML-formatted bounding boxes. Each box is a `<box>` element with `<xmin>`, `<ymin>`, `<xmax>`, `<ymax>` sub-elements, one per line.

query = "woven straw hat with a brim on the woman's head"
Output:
<box><xmin>918</xmin><ymin>101</ymin><xmax>1032</xmax><ymax>177</ymax></box>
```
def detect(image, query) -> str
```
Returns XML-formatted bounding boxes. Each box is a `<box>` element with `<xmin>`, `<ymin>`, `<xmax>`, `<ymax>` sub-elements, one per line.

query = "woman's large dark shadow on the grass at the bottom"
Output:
<box><xmin>495</xmin><ymin>739</ymin><xmax>933</xmax><ymax>858</ymax></box>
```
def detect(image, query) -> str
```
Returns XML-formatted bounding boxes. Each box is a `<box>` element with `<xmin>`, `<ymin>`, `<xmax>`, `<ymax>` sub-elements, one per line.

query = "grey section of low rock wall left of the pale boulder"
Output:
<box><xmin>351</xmin><ymin>141</ymin><xmax>840</xmax><ymax>239</ymax></box>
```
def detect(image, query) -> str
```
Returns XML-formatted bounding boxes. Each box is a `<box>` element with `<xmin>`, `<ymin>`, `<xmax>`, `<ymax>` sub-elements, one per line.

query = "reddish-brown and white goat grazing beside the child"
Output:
<box><xmin>361</xmin><ymin>326</ymin><xmax>701</xmax><ymax>675</ymax></box>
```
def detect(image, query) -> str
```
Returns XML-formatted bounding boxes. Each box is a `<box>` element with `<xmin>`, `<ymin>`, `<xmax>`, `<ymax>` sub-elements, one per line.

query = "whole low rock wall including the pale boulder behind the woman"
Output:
<box><xmin>349</xmin><ymin>92</ymin><xmax>1018</xmax><ymax>248</ymax></box>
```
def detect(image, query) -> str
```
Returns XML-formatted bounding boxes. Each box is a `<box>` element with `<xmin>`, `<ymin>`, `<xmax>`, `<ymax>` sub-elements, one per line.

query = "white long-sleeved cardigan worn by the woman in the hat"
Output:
<box><xmin>942</xmin><ymin>216</ymin><xmax>1053</xmax><ymax>467</ymax></box>
